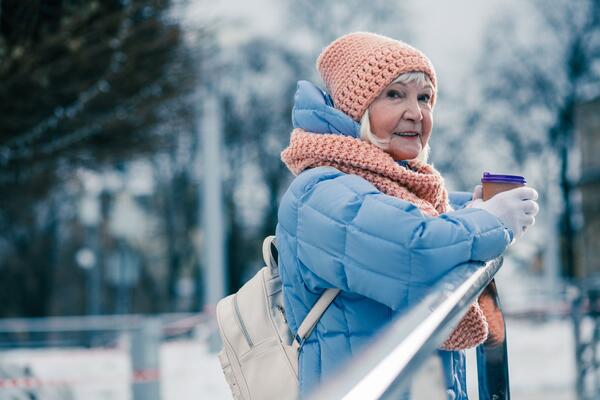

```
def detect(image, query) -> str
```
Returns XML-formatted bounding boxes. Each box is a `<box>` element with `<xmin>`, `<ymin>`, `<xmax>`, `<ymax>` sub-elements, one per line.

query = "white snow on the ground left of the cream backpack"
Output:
<box><xmin>0</xmin><ymin>340</ymin><xmax>230</xmax><ymax>400</ymax></box>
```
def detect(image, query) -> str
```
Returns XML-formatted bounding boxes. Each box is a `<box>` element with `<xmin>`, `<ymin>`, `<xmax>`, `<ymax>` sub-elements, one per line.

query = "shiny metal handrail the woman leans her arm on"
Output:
<box><xmin>310</xmin><ymin>257</ymin><xmax>503</xmax><ymax>400</ymax></box>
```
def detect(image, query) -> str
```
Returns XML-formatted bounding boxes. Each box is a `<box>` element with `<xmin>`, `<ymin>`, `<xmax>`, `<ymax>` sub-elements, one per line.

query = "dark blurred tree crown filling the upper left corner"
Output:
<box><xmin>0</xmin><ymin>0</ymin><xmax>195</xmax><ymax>194</ymax></box>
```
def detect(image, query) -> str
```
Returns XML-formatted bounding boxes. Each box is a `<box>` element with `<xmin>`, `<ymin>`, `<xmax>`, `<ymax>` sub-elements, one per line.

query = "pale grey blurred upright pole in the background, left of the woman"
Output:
<box><xmin>199</xmin><ymin>91</ymin><xmax>225</xmax><ymax>306</ymax></box>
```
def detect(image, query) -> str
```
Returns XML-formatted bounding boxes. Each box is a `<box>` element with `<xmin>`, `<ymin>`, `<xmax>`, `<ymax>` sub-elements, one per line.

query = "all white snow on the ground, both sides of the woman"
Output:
<box><xmin>0</xmin><ymin>319</ymin><xmax>575</xmax><ymax>400</ymax></box>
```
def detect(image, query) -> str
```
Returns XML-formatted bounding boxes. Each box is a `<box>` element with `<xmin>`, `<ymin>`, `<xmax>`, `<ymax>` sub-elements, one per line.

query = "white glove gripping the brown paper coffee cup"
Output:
<box><xmin>469</xmin><ymin>186</ymin><xmax>540</xmax><ymax>241</ymax></box>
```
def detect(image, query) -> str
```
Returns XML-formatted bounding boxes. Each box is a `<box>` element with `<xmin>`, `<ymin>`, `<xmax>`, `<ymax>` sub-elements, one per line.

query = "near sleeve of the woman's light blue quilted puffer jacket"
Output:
<box><xmin>279</xmin><ymin>167</ymin><xmax>509</xmax><ymax>310</ymax></box>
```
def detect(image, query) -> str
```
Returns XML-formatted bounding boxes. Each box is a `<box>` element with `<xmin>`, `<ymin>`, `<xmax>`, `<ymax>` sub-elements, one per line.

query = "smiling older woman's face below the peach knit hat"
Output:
<box><xmin>369</xmin><ymin>82</ymin><xmax>434</xmax><ymax>160</ymax></box>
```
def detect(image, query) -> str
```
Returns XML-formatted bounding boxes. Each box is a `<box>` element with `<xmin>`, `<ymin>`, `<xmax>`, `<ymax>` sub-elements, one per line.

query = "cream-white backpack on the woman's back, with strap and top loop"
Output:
<box><xmin>217</xmin><ymin>236</ymin><xmax>339</xmax><ymax>400</ymax></box>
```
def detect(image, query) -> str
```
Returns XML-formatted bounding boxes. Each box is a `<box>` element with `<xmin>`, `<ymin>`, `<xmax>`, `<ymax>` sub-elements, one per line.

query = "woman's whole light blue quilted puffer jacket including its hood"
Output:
<box><xmin>276</xmin><ymin>81</ymin><xmax>510</xmax><ymax>399</ymax></box>
